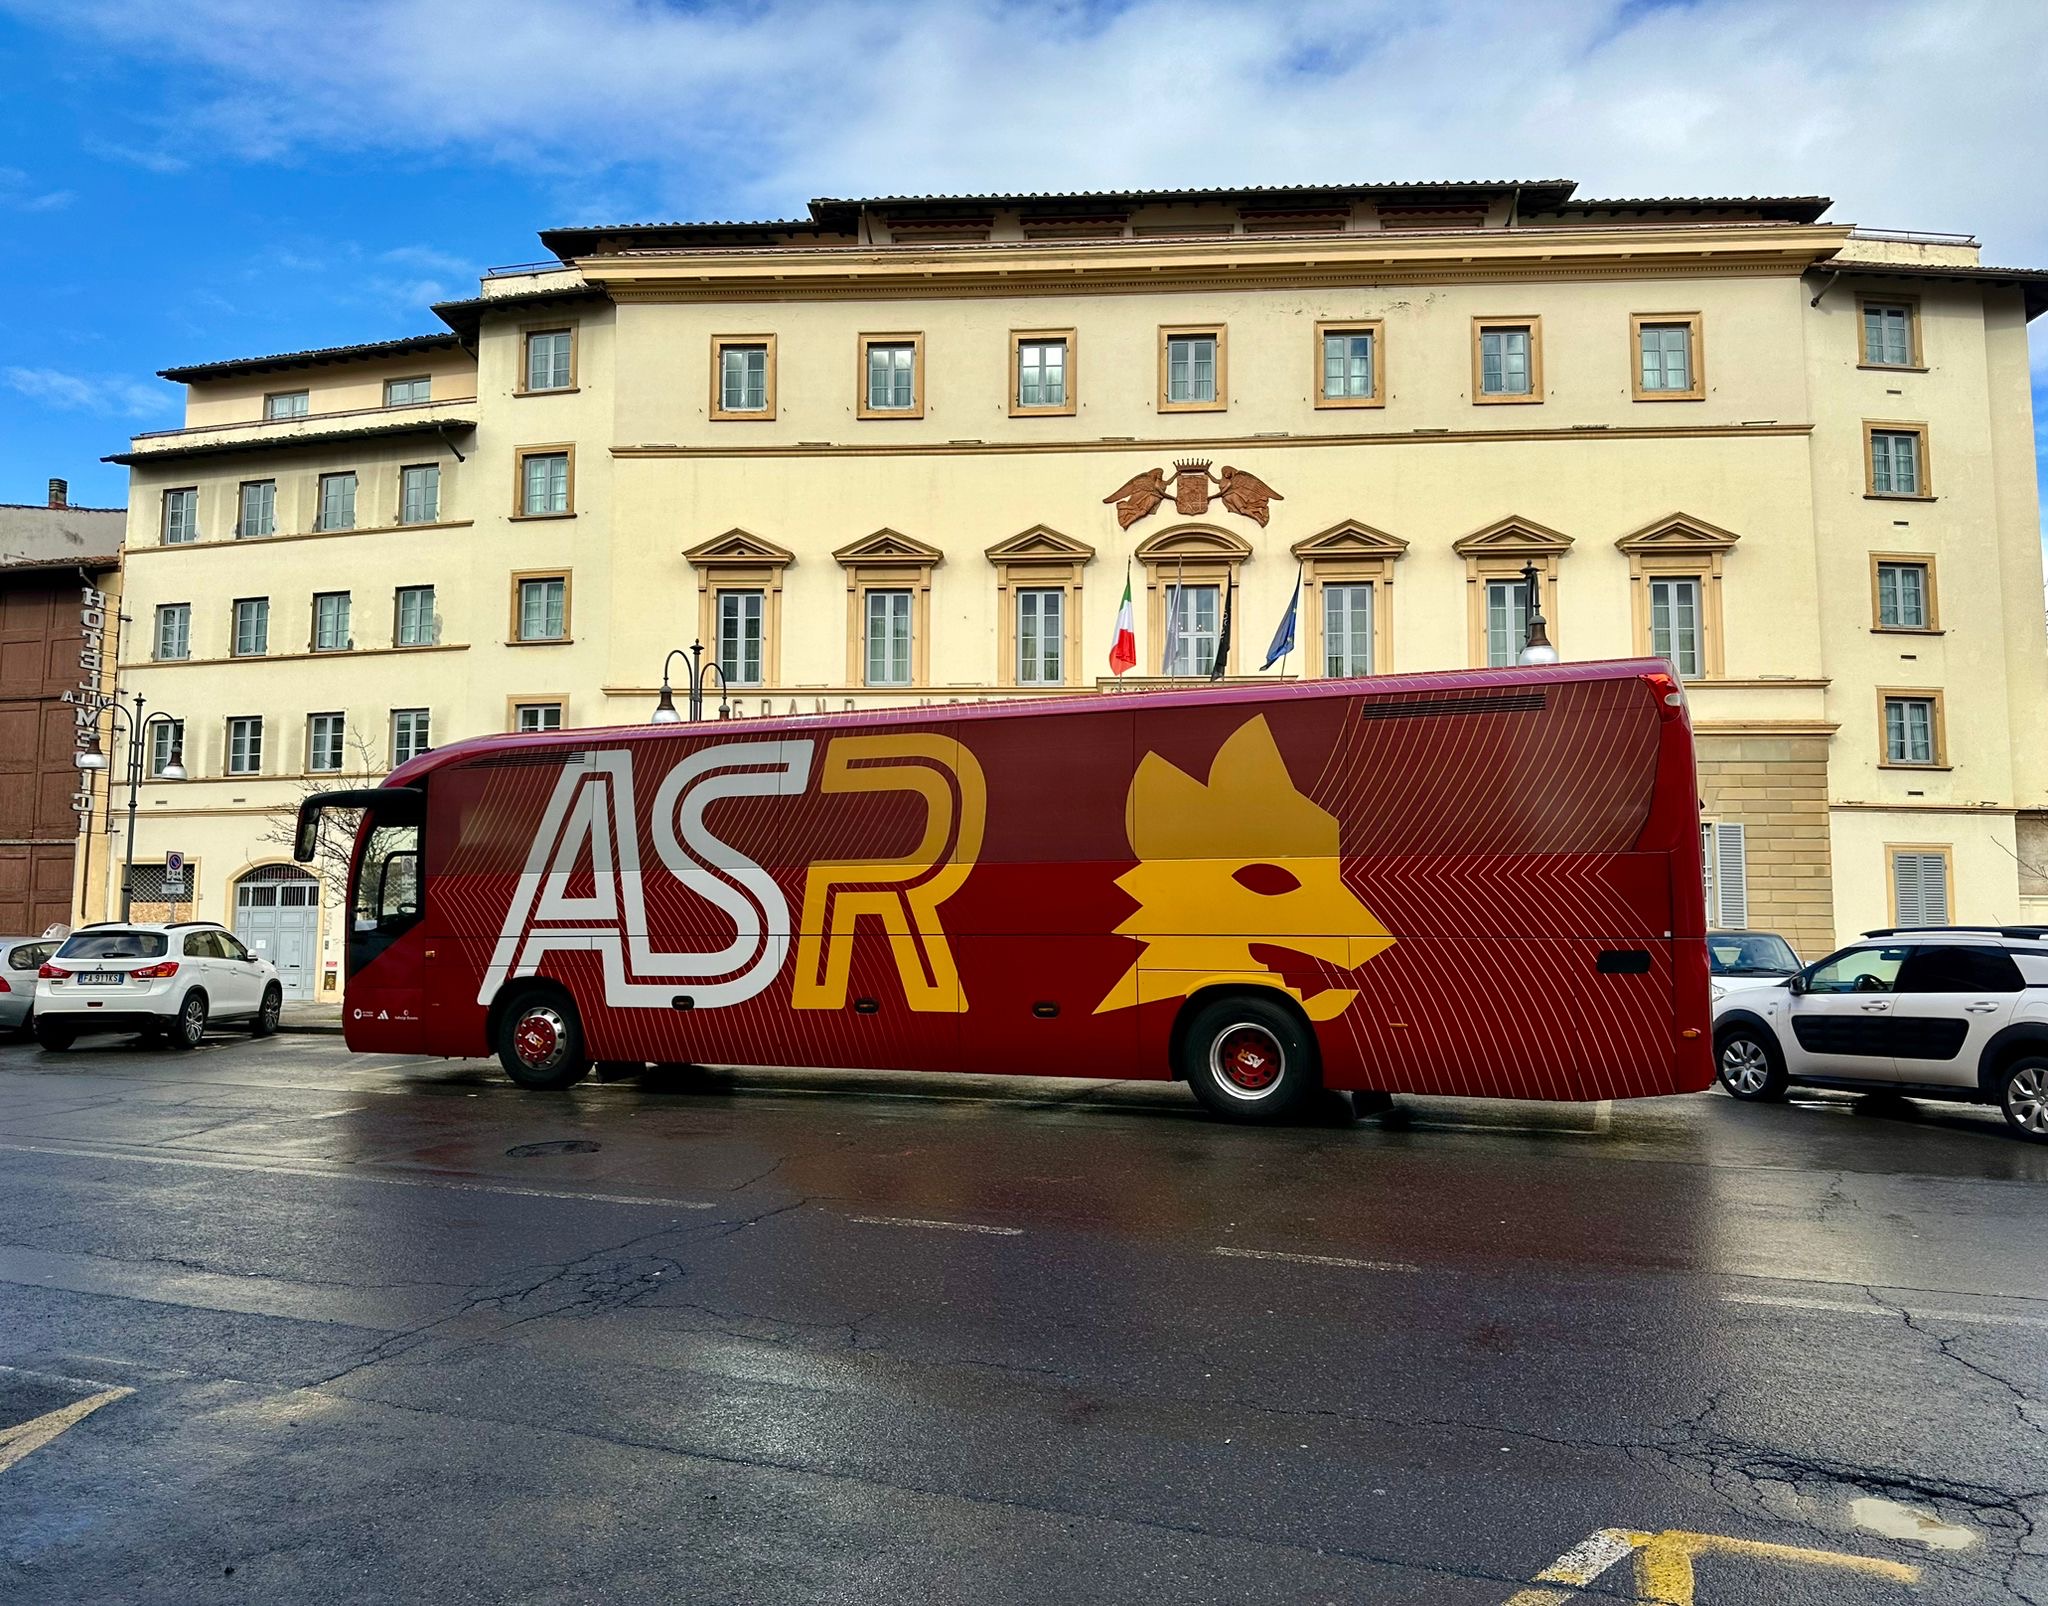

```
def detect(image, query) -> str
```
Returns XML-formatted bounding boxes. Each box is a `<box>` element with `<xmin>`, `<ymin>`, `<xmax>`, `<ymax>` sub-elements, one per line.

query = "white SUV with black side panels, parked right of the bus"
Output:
<box><xmin>1714</xmin><ymin>926</ymin><xmax>2048</xmax><ymax>1143</ymax></box>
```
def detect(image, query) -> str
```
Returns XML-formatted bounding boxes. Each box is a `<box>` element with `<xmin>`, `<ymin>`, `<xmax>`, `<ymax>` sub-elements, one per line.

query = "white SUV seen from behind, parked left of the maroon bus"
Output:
<box><xmin>35</xmin><ymin>920</ymin><xmax>285</xmax><ymax>1049</ymax></box>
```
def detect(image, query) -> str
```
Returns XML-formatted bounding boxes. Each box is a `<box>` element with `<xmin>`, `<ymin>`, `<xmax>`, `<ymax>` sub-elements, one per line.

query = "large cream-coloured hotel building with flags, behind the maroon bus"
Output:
<box><xmin>117</xmin><ymin>182</ymin><xmax>2048</xmax><ymax>987</ymax></box>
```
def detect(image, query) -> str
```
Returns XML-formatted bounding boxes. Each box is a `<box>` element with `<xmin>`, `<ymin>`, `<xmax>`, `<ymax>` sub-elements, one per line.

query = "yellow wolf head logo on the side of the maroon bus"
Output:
<box><xmin>1096</xmin><ymin>715</ymin><xmax>1393</xmax><ymax>1020</ymax></box>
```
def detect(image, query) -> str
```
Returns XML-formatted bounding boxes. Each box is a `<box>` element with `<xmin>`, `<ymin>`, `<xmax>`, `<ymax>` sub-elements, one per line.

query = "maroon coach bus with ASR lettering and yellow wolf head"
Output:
<box><xmin>297</xmin><ymin>662</ymin><xmax>1712</xmax><ymax>1121</ymax></box>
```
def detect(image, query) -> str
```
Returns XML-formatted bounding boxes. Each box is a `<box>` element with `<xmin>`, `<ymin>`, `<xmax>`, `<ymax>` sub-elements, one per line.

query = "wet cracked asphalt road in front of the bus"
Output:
<box><xmin>0</xmin><ymin>1037</ymin><xmax>2048</xmax><ymax>1606</ymax></box>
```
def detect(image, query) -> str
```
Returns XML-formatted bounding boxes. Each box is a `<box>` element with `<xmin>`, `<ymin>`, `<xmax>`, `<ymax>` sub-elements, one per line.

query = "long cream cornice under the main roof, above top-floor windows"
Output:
<box><xmin>578</xmin><ymin>223</ymin><xmax>1849</xmax><ymax>301</ymax></box>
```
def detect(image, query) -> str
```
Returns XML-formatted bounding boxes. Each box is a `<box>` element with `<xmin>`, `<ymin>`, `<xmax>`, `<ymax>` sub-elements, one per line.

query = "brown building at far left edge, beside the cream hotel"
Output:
<box><xmin>0</xmin><ymin>479</ymin><xmax>127</xmax><ymax>936</ymax></box>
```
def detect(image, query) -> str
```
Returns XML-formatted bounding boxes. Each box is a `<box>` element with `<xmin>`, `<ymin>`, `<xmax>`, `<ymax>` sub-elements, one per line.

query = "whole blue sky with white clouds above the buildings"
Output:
<box><xmin>0</xmin><ymin>0</ymin><xmax>2048</xmax><ymax>581</ymax></box>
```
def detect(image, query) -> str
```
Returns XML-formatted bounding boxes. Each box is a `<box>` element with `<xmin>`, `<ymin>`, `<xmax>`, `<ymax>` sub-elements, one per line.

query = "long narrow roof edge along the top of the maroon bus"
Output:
<box><xmin>383</xmin><ymin>658</ymin><xmax>1671</xmax><ymax>787</ymax></box>
